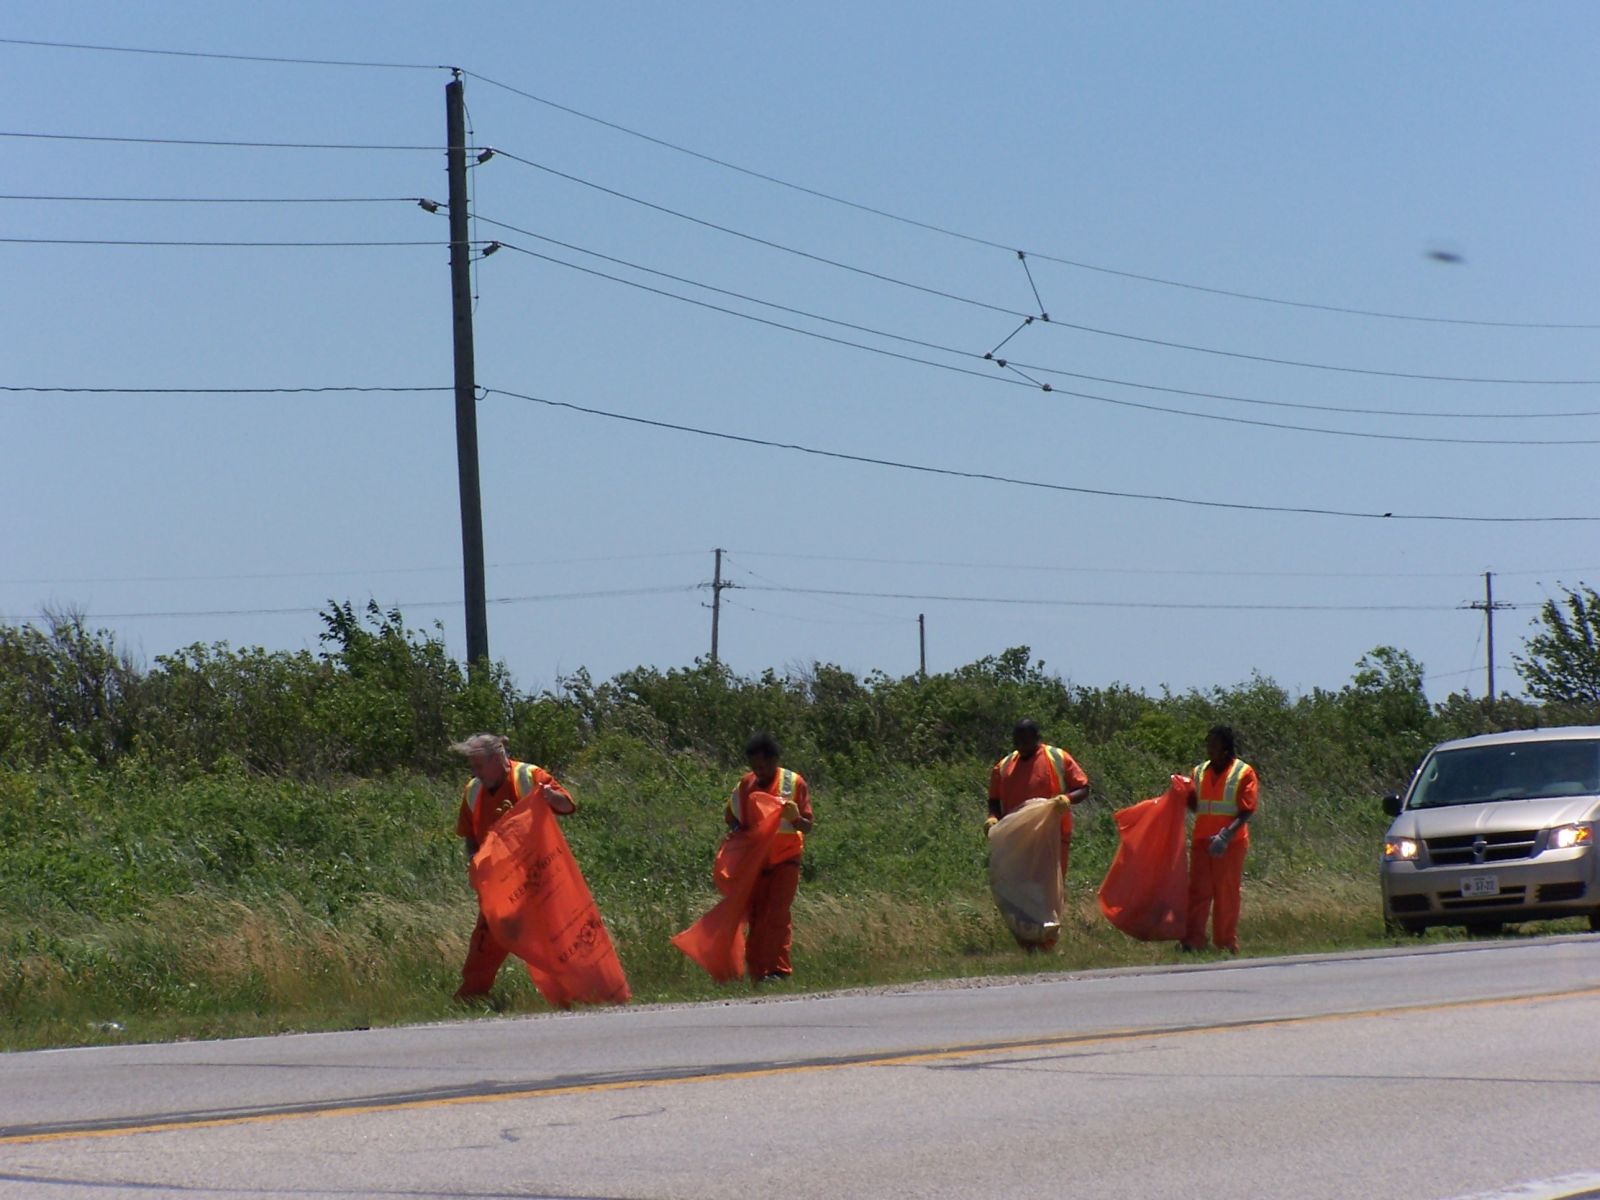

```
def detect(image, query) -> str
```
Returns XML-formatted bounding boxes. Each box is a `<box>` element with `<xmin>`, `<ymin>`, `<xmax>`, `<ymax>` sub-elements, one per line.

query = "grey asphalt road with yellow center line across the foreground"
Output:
<box><xmin>0</xmin><ymin>936</ymin><xmax>1600</xmax><ymax>1200</ymax></box>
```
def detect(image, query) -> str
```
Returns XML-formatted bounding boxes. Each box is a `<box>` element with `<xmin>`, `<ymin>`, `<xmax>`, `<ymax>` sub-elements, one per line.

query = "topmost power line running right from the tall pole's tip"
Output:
<box><xmin>462</xmin><ymin>70</ymin><xmax>1600</xmax><ymax>330</ymax></box>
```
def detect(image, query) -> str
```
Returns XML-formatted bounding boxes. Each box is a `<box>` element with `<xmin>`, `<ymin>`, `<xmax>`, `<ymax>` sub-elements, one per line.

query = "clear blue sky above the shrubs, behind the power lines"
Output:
<box><xmin>0</xmin><ymin>3</ymin><xmax>1600</xmax><ymax>698</ymax></box>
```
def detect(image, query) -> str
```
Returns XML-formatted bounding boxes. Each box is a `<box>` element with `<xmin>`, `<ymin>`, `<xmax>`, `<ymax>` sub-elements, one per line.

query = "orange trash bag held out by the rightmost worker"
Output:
<box><xmin>1099</xmin><ymin>774</ymin><xmax>1190</xmax><ymax>942</ymax></box>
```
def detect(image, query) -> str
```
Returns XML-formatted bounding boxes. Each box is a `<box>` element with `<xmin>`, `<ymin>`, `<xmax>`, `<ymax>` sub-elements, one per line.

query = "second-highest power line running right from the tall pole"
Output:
<box><xmin>494</xmin><ymin>162</ymin><xmax>1600</xmax><ymax>387</ymax></box>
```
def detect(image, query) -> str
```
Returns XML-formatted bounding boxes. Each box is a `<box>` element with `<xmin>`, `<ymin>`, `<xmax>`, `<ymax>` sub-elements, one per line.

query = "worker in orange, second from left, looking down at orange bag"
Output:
<box><xmin>723</xmin><ymin>733</ymin><xmax>811</xmax><ymax>984</ymax></box>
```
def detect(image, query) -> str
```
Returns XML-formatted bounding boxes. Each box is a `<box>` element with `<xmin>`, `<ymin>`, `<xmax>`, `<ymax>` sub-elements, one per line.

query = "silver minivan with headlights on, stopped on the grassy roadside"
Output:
<box><xmin>1382</xmin><ymin>725</ymin><xmax>1600</xmax><ymax>933</ymax></box>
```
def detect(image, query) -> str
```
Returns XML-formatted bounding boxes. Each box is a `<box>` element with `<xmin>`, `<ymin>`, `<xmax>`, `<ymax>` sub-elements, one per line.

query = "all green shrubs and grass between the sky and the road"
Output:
<box><xmin>0</xmin><ymin>605</ymin><xmax>1595</xmax><ymax>1048</ymax></box>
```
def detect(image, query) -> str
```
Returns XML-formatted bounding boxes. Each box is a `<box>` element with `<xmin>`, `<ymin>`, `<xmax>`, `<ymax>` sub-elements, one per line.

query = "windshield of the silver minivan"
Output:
<box><xmin>1406</xmin><ymin>739</ymin><xmax>1600</xmax><ymax>808</ymax></box>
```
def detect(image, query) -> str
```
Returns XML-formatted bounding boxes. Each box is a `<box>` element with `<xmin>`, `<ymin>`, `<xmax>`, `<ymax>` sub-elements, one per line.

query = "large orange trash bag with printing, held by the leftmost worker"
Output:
<box><xmin>470</xmin><ymin>787</ymin><xmax>632</xmax><ymax>1008</ymax></box>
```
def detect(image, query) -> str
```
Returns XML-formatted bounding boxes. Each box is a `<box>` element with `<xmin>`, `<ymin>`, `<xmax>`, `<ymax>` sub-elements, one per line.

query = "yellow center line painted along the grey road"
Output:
<box><xmin>0</xmin><ymin>987</ymin><xmax>1600</xmax><ymax>1146</ymax></box>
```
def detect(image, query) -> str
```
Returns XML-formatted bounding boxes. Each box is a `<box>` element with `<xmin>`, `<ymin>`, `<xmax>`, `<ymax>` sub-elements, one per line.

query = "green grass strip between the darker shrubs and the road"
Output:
<box><xmin>0</xmin><ymin>744</ymin><xmax>1548</xmax><ymax>1050</ymax></box>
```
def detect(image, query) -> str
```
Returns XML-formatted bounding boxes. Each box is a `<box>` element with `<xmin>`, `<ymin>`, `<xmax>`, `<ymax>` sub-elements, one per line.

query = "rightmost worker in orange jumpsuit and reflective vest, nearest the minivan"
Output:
<box><xmin>1178</xmin><ymin>725</ymin><xmax>1259</xmax><ymax>954</ymax></box>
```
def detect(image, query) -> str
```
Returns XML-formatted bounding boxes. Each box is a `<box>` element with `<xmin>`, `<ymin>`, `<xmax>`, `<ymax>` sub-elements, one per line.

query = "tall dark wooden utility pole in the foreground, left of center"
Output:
<box><xmin>445</xmin><ymin>70</ymin><xmax>490</xmax><ymax>672</ymax></box>
